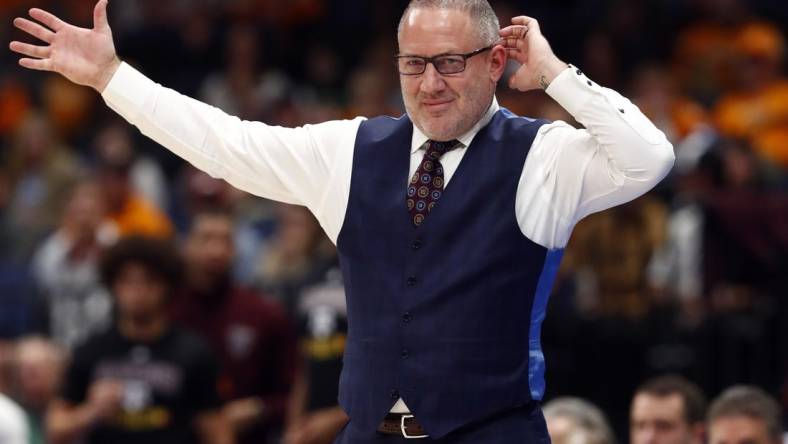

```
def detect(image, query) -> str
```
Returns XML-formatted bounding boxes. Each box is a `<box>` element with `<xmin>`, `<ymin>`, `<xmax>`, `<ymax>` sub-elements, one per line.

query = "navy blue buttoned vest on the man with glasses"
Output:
<box><xmin>337</xmin><ymin>110</ymin><xmax>562</xmax><ymax>438</ymax></box>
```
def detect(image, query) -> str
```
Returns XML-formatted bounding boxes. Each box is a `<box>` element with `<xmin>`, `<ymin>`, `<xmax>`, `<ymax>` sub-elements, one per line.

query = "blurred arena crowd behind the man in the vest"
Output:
<box><xmin>0</xmin><ymin>0</ymin><xmax>788</xmax><ymax>444</ymax></box>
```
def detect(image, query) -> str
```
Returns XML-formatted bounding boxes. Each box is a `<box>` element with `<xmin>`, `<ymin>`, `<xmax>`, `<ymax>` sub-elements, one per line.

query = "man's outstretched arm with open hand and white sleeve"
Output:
<box><xmin>10</xmin><ymin>0</ymin><xmax>362</xmax><ymax>240</ymax></box>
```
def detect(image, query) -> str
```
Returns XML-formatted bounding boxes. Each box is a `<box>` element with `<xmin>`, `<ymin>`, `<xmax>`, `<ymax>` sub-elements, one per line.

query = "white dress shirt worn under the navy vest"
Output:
<box><xmin>102</xmin><ymin>63</ymin><xmax>675</xmax><ymax>411</ymax></box>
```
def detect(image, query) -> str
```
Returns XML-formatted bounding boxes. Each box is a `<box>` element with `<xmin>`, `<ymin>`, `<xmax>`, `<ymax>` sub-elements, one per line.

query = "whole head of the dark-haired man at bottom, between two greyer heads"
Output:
<box><xmin>630</xmin><ymin>375</ymin><xmax>706</xmax><ymax>444</ymax></box>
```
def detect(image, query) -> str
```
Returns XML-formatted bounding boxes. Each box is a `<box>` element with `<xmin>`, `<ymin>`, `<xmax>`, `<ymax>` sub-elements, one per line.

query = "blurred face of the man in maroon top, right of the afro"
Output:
<box><xmin>184</xmin><ymin>214</ymin><xmax>235</xmax><ymax>281</ymax></box>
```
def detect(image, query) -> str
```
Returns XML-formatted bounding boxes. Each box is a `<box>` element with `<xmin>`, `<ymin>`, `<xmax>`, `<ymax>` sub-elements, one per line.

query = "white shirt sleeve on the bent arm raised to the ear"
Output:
<box><xmin>516</xmin><ymin>67</ymin><xmax>675</xmax><ymax>249</ymax></box>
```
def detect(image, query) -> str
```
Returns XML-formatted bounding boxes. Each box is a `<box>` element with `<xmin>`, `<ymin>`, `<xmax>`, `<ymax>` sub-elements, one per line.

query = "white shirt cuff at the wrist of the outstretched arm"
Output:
<box><xmin>101</xmin><ymin>62</ymin><xmax>156</xmax><ymax>122</ymax></box>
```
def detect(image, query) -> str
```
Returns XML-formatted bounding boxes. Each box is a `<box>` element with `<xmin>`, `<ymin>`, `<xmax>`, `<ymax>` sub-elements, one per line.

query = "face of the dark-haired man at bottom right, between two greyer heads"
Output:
<box><xmin>630</xmin><ymin>393</ymin><xmax>702</xmax><ymax>444</ymax></box>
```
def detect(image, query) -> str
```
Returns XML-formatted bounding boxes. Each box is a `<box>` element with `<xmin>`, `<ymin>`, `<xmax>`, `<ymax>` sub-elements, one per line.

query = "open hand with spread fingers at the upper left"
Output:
<box><xmin>10</xmin><ymin>0</ymin><xmax>120</xmax><ymax>93</ymax></box>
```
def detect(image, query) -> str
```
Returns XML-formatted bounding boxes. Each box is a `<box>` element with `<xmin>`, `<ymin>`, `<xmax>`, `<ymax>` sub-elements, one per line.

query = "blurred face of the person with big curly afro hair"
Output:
<box><xmin>112</xmin><ymin>262</ymin><xmax>168</xmax><ymax>324</ymax></box>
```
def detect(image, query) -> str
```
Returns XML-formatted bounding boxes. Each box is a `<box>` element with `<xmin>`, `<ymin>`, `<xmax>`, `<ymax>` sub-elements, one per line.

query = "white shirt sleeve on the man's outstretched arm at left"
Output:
<box><xmin>102</xmin><ymin>63</ymin><xmax>364</xmax><ymax>241</ymax></box>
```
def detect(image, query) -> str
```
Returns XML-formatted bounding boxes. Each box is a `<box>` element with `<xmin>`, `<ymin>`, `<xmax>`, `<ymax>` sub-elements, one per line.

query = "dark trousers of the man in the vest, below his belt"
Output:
<box><xmin>334</xmin><ymin>403</ymin><xmax>550</xmax><ymax>444</ymax></box>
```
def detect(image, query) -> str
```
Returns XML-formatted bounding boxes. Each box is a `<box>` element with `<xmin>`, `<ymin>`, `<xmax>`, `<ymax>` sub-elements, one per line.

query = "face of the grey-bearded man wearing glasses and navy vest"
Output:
<box><xmin>399</xmin><ymin>8</ymin><xmax>506</xmax><ymax>141</ymax></box>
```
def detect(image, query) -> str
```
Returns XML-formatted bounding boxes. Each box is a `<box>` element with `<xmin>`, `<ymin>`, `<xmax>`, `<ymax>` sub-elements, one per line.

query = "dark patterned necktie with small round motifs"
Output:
<box><xmin>408</xmin><ymin>140</ymin><xmax>459</xmax><ymax>227</ymax></box>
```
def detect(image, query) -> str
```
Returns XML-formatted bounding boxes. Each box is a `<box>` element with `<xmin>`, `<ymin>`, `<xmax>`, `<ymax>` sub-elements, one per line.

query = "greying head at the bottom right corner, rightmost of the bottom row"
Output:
<box><xmin>708</xmin><ymin>386</ymin><xmax>783</xmax><ymax>444</ymax></box>
